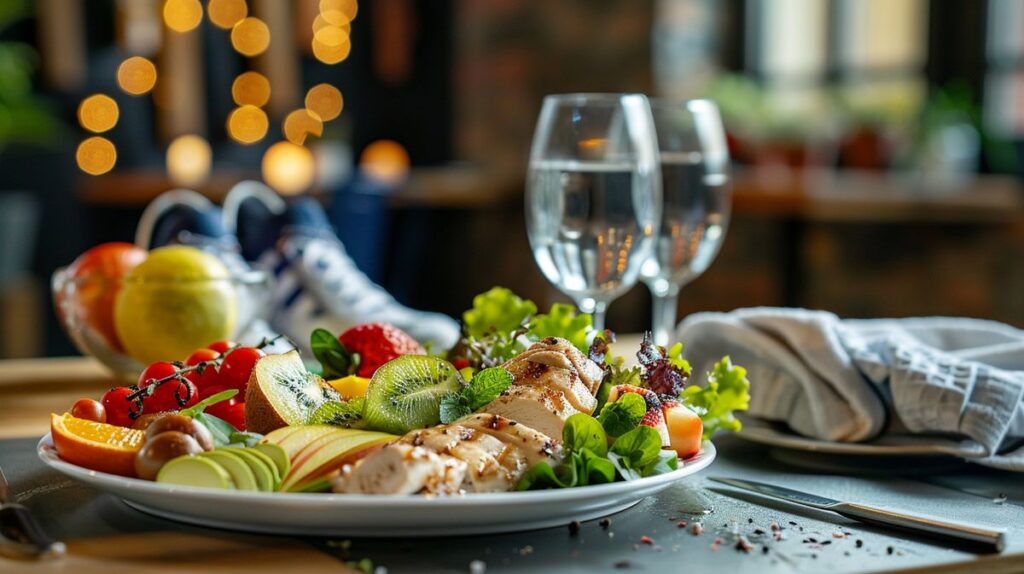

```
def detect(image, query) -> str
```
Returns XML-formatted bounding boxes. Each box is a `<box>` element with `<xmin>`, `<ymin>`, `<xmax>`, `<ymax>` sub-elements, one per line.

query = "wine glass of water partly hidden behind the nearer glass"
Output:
<box><xmin>641</xmin><ymin>99</ymin><xmax>731</xmax><ymax>347</ymax></box>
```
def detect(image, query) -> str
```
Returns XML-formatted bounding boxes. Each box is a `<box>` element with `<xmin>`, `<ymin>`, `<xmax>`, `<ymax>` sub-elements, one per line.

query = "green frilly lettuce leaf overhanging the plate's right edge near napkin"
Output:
<box><xmin>679</xmin><ymin>356</ymin><xmax>751</xmax><ymax>440</ymax></box>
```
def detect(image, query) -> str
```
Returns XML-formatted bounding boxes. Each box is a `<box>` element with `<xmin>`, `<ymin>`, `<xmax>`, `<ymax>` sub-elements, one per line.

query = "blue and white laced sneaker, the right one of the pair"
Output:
<box><xmin>224</xmin><ymin>181</ymin><xmax>459</xmax><ymax>349</ymax></box>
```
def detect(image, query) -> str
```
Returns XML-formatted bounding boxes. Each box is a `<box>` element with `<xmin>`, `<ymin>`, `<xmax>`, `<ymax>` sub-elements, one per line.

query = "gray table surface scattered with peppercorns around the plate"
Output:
<box><xmin>0</xmin><ymin>437</ymin><xmax>1024</xmax><ymax>574</ymax></box>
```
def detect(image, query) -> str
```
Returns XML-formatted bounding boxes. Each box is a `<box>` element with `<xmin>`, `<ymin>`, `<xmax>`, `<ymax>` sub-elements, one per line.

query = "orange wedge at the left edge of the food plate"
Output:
<box><xmin>50</xmin><ymin>412</ymin><xmax>145</xmax><ymax>477</ymax></box>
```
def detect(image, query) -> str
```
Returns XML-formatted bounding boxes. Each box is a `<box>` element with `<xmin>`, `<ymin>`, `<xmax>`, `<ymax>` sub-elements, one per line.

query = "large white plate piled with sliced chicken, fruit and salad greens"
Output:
<box><xmin>39</xmin><ymin>288</ymin><xmax>750</xmax><ymax>536</ymax></box>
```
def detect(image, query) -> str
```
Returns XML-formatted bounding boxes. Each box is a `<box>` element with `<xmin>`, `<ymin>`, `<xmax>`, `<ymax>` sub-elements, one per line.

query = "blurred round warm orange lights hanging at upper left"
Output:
<box><xmin>76</xmin><ymin>0</ymin><xmax>358</xmax><ymax>194</ymax></box>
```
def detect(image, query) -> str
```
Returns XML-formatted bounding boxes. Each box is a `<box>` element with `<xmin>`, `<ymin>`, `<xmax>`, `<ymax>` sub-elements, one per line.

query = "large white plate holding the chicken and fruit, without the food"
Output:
<box><xmin>37</xmin><ymin>434</ymin><xmax>715</xmax><ymax>537</ymax></box>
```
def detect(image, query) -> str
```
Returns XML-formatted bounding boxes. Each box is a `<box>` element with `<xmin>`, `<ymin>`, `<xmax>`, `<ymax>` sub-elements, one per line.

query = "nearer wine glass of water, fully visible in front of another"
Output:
<box><xmin>526</xmin><ymin>94</ymin><xmax>662</xmax><ymax>329</ymax></box>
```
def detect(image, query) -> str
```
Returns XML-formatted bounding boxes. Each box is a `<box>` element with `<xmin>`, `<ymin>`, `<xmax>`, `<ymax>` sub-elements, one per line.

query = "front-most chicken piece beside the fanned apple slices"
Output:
<box><xmin>332</xmin><ymin>443</ymin><xmax>466</xmax><ymax>494</ymax></box>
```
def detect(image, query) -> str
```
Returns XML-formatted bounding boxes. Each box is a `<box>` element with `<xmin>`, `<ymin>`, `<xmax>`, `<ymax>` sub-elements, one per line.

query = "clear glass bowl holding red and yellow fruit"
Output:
<box><xmin>50</xmin><ymin>267</ymin><xmax>270</xmax><ymax>382</ymax></box>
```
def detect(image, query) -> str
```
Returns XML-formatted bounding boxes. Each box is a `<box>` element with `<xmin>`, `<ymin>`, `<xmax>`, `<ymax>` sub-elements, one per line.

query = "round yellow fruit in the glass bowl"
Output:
<box><xmin>114</xmin><ymin>246</ymin><xmax>238</xmax><ymax>363</ymax></box>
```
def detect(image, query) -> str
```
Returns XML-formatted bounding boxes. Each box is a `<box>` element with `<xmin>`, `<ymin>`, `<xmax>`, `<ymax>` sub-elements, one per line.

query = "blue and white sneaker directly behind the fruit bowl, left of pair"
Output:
<box><xmin>135</xmin><ymin>189</ymin><xmax>289</xmax><ymax>349</ymax></box>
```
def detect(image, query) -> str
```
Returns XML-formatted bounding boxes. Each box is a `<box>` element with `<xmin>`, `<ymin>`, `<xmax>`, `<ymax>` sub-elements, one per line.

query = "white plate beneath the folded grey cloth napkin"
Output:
<box><xmin>736</xmin><ymin>416</ymin><xmax>986</xmax><ymax>458</ymax></box>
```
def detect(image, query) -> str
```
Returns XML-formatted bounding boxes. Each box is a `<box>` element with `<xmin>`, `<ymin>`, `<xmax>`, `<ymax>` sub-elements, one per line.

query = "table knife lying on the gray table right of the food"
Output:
<box><xmin>709</xmin><ymin>477</ymin><xmax>1006</xmax><ymax>553</ymax></box>
